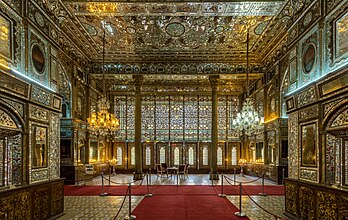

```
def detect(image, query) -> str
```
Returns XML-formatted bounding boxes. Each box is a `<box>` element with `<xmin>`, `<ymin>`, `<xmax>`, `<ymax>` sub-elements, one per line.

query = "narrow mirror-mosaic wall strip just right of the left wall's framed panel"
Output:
<box><xmin>49</xmin><ymin>113</ymin><xmax>60</xmax><ymax>179</ymax></box>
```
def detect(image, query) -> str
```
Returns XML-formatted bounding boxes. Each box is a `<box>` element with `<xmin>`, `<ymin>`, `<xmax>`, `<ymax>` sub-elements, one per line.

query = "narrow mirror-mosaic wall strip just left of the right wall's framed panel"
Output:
<box><xmin>288</xmin><ymin>112</ymin><xmax>299</xmax><ymax>179</ymax></box>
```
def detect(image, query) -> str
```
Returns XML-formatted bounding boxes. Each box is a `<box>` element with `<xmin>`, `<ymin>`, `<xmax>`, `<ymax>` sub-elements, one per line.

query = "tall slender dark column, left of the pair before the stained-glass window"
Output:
<box><xmin>133</xmin><ymin>75</ymin><xmax>143</xmax><ymax>180</ymax></box>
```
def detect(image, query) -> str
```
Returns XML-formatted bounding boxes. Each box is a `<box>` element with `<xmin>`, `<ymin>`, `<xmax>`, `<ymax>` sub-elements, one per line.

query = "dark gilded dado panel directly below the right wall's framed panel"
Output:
<box><xmin>299</xmin><ymin>186</ymin><xmax>316</xmax><ymax>220</ymax></box>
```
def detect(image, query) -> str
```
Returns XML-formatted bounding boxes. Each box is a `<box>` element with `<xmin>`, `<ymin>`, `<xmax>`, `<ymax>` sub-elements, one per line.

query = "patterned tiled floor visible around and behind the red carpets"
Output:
<box><xmin>59</xmin><ymin>174</ymin><xmax>286</xmax><ymax>220</ymax></box>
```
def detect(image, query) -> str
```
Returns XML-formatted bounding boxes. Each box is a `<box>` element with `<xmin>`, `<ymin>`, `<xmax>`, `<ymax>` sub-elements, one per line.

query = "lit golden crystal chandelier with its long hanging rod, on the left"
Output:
<box><xmin>87</xmin><ymin>22</ymin><xmax>120</xmax><ymax>137</ymax></box>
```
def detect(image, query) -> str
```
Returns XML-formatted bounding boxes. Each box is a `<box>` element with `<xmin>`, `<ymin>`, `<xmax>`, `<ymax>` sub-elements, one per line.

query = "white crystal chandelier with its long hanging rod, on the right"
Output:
<box><xmin>232</xmin><ymin>29</ymin><xmax>264</xmax><ymax>135</ymax></box>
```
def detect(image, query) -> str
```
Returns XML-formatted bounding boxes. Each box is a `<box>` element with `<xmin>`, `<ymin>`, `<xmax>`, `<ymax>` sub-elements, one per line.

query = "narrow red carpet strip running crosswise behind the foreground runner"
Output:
<box><xmin>64</xmin><ymin>185</ymin><xmax>284</xmax><ymax>196</ymax></box>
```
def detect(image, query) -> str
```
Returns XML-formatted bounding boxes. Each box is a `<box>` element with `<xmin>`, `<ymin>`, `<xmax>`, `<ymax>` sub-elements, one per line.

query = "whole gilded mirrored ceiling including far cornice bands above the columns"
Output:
<box><xmin>59</xmin><ymin>0</ymin><xmax>287</xmax><ymax>92</ymax></box>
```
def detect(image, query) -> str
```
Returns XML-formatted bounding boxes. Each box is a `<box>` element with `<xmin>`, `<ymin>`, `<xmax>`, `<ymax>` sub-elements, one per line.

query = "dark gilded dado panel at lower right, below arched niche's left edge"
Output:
<box><xmin>317</xmin><ymin>191</ymin><xmax>337</xmax><ymax>220</ymax></box>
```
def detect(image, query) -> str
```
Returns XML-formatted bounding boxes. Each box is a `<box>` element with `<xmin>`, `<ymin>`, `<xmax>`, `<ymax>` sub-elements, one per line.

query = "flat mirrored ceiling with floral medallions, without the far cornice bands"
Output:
<box><xmin>64</xmin><ymin>1</ymin><xmax>285</xmax><ymax>62</ymax></box>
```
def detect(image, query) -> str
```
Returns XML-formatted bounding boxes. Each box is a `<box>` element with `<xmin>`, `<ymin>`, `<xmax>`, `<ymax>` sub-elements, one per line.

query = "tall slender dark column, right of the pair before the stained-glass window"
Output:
<box><xmin>209</xmin><ymin>75</ymin><xmax>220</xmax><ymax>180</ymax></box>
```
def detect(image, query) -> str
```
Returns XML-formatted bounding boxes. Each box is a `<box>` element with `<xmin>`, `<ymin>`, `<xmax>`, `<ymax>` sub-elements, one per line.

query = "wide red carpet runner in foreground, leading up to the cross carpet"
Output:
<box><xmin>132</xmin><ymin>194</ymin><xmax>248</xmax><ymax>220</ymax></box>
